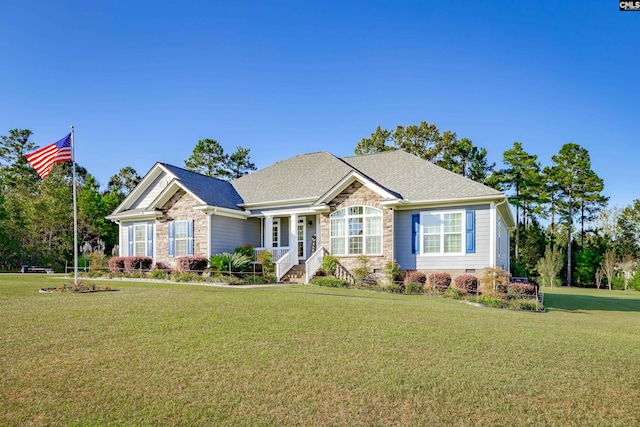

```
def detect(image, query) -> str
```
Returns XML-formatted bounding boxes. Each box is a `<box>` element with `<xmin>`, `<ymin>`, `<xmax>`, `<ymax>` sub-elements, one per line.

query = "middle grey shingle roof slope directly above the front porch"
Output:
<box><xmin>232</xmin><ymin>152</ymin><xmax>352</xmax><ymax>204</ymax></box>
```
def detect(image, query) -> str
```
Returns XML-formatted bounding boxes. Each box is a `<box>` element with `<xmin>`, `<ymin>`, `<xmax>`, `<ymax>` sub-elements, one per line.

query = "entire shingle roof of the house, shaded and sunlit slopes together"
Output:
<box><xmin>154</xmin><ymin>151</ymin><xmax>503</xmax><ymax>210</ymax></box>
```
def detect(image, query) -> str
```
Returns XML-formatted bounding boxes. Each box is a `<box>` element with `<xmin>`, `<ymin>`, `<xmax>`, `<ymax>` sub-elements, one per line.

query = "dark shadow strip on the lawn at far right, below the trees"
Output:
<box><xmin>544</xmin><ymin>293</ymin><xmax>640</xmax><ymax>313</ymax></box>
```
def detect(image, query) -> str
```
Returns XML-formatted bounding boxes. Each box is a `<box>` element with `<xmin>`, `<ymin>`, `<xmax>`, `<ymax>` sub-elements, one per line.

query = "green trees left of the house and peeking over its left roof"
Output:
<box><xmin>0</xmin><ymin>129</ymin><xmax>256</xmax><ymax>271</ymax></box>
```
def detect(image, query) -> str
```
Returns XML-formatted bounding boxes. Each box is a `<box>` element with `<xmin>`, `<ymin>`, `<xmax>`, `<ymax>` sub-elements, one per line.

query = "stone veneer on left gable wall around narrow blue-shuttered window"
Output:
<box><xmin>155</xmin><ymin>190</ymin><xmax>208</xmax><ymax>267</ymax></box>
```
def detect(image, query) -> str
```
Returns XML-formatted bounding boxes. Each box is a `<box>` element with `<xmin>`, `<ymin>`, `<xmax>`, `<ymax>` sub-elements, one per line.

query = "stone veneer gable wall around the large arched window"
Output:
<box><xmin>320</xmin><ymin>181</ymin><xmax>394</xmax><ymax>278</ymax></box>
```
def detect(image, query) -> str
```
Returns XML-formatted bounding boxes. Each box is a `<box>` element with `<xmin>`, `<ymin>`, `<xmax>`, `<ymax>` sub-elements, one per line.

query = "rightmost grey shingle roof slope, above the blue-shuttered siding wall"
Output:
<box><xmin>343</xmin><ymin>151</ymin><xmax>503</xmax><ymax>202</ymax></box>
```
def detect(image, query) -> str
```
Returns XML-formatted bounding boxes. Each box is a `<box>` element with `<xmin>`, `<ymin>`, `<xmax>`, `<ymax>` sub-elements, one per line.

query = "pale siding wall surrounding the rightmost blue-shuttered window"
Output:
<box><xmin>394</xmin><ymin>204</ymin><xmax>490</xmax><ymax>270</ymax></box>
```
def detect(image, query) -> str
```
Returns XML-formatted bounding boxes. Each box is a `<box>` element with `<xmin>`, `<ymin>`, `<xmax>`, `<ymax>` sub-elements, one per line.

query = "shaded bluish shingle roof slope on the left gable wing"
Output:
<box><xmin>161</xmin><ymin>163</ymin><xmax>243</xmax><ymax>210</ymax></box>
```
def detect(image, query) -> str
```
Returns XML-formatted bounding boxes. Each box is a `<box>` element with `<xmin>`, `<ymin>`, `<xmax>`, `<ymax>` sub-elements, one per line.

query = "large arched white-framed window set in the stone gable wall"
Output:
<box><xmin>329</xmin><ymin>206</ymin><xmax>382</xmax><ymax>255</ymax></box>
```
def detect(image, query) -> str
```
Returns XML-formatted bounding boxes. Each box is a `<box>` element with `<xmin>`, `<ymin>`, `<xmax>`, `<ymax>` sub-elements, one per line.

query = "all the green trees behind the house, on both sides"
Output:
<box><xmin>0</xmin><ymin>121</ymin><xmax>640</xmax><ymax>285</ymax></box>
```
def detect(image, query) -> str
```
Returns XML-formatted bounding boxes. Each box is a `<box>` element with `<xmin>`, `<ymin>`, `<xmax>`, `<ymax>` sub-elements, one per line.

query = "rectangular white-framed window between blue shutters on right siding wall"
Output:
<box><xmin>420</xmin><ymin>211</ymin><xmax>465</xmax><ymax>255</ymax></box>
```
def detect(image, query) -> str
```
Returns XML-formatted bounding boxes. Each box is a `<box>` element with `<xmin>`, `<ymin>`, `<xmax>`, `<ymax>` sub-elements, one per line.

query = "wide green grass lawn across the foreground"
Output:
<box><xmin>0</xmin><ymin>275</ymin><xmax>640</xmax><ymax>426</ymax></box>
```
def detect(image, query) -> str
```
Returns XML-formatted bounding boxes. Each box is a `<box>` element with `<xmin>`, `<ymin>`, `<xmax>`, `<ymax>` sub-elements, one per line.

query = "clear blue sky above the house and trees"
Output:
<box><xmin>0</xmin><ymin>0</ymin><xmax>640</xmax><ymax>206</ymax></box>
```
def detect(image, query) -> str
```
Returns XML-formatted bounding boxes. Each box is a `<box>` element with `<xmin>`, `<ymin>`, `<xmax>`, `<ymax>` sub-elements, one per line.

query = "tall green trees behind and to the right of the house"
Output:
<box><xmin>354</xmin><ymin>121</ymin><xmax>640</xmax><ymax>287</ymax></box>
